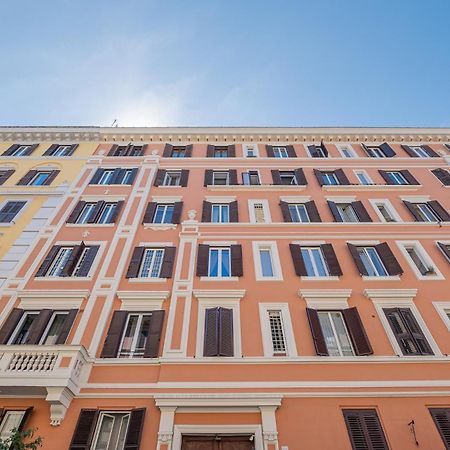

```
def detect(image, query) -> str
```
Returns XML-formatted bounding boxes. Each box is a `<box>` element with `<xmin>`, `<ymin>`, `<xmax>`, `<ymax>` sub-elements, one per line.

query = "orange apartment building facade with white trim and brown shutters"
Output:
<box><xmin>0</xmin><ymin>128</ymin><xmax>450</xmax><ymax>450</ymax></box>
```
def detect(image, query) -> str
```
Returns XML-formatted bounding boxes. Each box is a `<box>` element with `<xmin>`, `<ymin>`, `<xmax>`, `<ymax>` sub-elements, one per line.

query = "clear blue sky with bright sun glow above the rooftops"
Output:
<box><xmin>0</xmin><ymin>0</ymin><xmax>450</xmax><ymax>127</ymax></box>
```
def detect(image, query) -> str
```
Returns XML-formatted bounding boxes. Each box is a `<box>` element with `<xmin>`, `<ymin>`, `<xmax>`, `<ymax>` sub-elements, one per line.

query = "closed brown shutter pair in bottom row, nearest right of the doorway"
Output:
<box><xmin>343</xmin><ymin>409</ymin><xmax>389</xmax><ymax>450</ymax></box>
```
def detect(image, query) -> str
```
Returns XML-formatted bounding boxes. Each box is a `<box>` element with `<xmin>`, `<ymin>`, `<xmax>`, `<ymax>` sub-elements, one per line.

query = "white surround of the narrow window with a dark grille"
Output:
<box><xmin>258</xmin><ymin>303</ymin><xmax>297</xmax><ymax>358</ymax></box>
